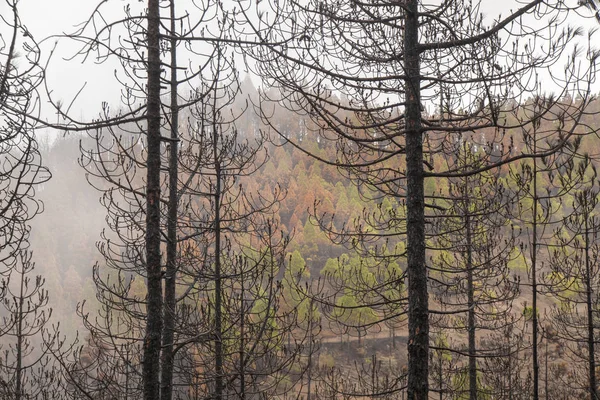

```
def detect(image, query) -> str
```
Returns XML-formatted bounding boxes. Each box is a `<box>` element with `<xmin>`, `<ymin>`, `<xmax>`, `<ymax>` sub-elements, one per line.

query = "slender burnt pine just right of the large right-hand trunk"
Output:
<box><xmin>429</xmin><ymin>142</ymin><xmax>519</xmax><ymax>400</ymax></box>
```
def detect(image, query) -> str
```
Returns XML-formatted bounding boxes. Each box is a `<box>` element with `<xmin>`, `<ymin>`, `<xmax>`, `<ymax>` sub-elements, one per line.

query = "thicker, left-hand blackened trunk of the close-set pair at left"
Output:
<box><xmin>142</xmin><ymin>0</ymin><xmax>162</xmax><ymax>400</ymax></box>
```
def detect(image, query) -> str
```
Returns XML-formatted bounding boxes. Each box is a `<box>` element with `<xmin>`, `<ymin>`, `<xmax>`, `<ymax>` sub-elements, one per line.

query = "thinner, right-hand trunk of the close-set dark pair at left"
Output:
<box><xmin>160</xmin><ymin>0</ymin><xmax>179</xmax><ymax>400</ymax></box>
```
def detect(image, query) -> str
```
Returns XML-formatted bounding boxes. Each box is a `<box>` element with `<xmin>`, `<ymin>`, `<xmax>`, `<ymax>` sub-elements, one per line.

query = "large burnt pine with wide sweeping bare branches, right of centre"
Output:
<box><xmin>237</xmin><ymin>0</ymin><xmax>597</xmax><ymax>400</ymax></box>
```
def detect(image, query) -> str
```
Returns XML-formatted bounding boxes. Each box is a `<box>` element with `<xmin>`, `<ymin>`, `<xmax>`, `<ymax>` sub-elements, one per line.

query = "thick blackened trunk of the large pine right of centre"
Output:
<box><xmin>404</xmin><ymin>0</ymin><xmax>429</xmax><ymax>400</ymax></box>
